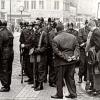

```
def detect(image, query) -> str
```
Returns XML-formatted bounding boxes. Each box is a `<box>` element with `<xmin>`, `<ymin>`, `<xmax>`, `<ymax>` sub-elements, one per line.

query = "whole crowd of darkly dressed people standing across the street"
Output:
<box><xmin>0</xmin><ymin>18</ymin><xmax>100</xmax><ymax>99</ymax></box>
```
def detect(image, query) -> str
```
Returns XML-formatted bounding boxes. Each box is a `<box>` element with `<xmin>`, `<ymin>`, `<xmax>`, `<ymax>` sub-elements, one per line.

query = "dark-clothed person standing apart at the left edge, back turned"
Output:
<box><xmin>0</xmin><ymin>21</ymin><xmax>14</xmax><ymax>92</ymax></box>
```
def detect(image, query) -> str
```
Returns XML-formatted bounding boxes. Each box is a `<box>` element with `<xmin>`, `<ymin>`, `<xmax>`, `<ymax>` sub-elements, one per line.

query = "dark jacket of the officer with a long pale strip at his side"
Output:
<box><xmin>32</xmin><ymin>29</ymin><xmax>47</xmax><ymax>64</ymax></box>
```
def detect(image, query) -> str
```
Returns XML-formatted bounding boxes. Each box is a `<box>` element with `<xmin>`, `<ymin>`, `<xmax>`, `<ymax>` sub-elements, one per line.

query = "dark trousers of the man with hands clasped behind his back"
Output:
<box><xmin>56</xmin><ymin>65</ymin><xmax>77</xmax><ymax>97</ymax></box>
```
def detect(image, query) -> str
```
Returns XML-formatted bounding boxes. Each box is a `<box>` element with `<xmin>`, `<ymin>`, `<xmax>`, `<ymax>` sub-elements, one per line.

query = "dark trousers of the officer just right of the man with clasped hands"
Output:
<box><xmin>78</xmin><ymin>51</ymin><xmax>87</xmax><ymax>78</ymax></box>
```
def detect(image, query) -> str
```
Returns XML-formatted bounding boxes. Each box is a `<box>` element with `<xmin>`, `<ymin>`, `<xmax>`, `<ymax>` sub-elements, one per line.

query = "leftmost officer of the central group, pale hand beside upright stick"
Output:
<box><xmin>19</xmin><ymin>22</ymin><xmax>33</xmax><ymax>84</ymax></box>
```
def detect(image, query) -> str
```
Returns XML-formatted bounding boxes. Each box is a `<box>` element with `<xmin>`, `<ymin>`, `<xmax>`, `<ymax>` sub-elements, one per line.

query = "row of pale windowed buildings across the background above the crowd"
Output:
<box><xmin>0</xmin><ymin>0</ymin><xmax>94</xmax><ymax>23</ymax></box>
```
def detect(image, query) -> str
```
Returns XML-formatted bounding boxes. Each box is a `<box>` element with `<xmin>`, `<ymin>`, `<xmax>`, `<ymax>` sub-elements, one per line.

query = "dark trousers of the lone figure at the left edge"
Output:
<box><xmin>0</xmin><ymin>55</ymin><xmax>13</xmax><ymax>88</ymax></box>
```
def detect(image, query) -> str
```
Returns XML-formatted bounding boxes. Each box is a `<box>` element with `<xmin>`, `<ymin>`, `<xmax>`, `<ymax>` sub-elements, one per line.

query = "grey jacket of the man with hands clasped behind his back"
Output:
<box><xmin>53</xmin><ymin>31</ymin><xmax>79</xmax><ymax>66</ymax></box>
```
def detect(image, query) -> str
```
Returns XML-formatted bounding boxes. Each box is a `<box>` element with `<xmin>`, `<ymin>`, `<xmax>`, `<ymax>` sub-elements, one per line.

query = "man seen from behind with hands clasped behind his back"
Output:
<box><xmin>51</xmin><ymin>23</ymin><xmax>79</xmax><ymax>99</ymax></box>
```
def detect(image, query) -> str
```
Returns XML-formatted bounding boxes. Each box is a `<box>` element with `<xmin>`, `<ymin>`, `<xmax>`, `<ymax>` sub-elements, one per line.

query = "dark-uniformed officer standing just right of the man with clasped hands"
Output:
<box><xmin>78</xmin><ymin>20</ymin><xmax>90</xmax><ymax>83</ymax></box>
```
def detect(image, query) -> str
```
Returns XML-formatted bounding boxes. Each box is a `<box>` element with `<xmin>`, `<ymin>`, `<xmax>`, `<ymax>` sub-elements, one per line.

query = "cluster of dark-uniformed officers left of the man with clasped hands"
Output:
<box><xmin>19</xmin><ymin>18</ymin><xmax>57</xmax><ymax>90</ymax></box>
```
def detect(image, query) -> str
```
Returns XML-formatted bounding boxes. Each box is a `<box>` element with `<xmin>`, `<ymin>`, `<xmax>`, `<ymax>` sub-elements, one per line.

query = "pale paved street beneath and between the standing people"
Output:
<box><xmin>0</xmin><ymin>33</ymin><xmax>100</xmax><ymax>100</ymax></box>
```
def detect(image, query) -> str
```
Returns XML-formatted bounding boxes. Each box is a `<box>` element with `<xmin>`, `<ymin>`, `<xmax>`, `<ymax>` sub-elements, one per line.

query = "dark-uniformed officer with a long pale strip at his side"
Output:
<box><xmin>32</xmin><ymin>21</ymin><xmax>47</xmax><ymax>91</ymax></box>
